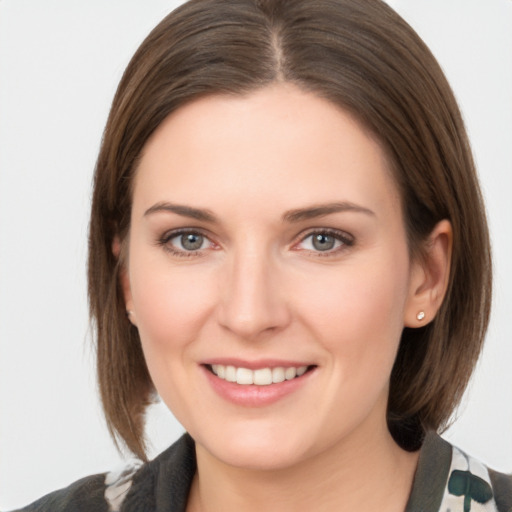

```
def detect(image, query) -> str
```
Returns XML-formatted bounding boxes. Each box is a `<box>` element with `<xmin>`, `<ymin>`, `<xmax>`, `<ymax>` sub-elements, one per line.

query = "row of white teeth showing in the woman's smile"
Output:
<box><xmin>211</xmin><ymin>364</ymin><xmax>308</xmax><ymax>386</ymax></box>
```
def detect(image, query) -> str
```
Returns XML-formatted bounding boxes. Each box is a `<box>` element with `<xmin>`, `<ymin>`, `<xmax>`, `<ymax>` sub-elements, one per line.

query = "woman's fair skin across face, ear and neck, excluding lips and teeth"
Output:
<box><xmin>121</xmin><ymin>84</ymin><xmax>451</xmax><ymax>511</ymax></box>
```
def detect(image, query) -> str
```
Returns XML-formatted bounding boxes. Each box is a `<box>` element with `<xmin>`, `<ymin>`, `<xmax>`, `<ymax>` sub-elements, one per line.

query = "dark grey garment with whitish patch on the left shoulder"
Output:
<box><xmin>10</xmin><ymin>434</ymin><xmax>196</xmax><ymax>512</ymax></box>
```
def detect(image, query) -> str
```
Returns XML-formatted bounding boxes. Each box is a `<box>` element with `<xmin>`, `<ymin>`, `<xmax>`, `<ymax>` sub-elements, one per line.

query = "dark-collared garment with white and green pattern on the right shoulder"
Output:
<box><xmin>407</xmin><ymin>433</ymin><xmax>512</xmax><ymax>512</ymax></box>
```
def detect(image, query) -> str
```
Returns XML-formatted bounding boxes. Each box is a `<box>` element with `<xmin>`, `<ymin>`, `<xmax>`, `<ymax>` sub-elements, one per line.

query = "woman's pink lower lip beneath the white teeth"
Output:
<box><xmin>203</xmin><ymin>366</ymin><xmax>314</xmax><ymax>407</ymax></box>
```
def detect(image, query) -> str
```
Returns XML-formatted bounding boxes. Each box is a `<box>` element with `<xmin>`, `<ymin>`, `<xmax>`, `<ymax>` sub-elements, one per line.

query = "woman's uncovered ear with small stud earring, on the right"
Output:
<box><xmin>404</xmin><ymin>220</ymin><xmax>453</xmax><ymax>327</ymax></box>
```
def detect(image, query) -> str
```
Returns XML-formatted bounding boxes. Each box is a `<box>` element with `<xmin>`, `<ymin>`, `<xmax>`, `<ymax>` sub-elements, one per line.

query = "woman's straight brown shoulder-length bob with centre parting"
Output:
<box><xmin>88</xmin><ymin>0</ymin><xmax>491</xmax><ymax>460</ymax></box>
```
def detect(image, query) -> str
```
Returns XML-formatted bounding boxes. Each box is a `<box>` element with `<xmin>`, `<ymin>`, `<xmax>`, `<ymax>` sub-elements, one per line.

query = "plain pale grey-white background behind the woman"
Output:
<box><xmin>0</xmin><ymin>0</ymin><xmax>512</xmax><ymax>509</ymax></box>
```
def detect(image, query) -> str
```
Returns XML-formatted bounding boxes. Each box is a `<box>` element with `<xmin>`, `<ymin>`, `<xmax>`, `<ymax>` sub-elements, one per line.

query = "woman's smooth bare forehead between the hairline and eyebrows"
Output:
<box><xmin>134</xmin><ymin>84</ymin><xmax>399</xmax><ymax>218</ymax></box>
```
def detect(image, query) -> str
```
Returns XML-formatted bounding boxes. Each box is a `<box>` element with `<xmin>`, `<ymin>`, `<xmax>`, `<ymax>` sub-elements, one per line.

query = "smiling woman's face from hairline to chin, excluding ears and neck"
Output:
<box><xmin>123</xmin><ymin>85</ymin><xmax>420</xmax><ymax>469</ymax></box>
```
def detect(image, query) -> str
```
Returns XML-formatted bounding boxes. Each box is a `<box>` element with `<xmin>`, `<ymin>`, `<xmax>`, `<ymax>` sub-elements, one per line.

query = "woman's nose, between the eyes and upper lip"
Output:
<box><xmin>218</xmin><ymin>246</ymin><xmax>291</xmax><ymax>340</ymax></box>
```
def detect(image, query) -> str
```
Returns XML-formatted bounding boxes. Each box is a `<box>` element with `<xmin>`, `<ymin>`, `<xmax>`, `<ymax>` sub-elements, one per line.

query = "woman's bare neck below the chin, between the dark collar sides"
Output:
<box><xmin>188</xmin><ymin>425</ymin><xmax>419</xmax><ymax>512</ymax></box>
